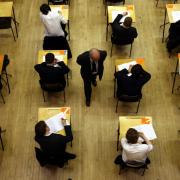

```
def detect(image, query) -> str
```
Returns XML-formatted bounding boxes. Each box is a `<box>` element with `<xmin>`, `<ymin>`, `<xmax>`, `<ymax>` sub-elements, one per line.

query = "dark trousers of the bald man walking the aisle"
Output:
<box><xmin>83</xmin><ymin>75</ymin><xmax>97</xmax><ymax>101</ymax></box>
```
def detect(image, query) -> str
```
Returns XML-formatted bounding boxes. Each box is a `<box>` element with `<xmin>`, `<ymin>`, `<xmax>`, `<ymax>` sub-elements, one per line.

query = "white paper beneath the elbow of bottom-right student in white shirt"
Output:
<box><xmin>133</xmin><ymin>124</ymin><xmax>157</xmax><ymax>140</ymax></box>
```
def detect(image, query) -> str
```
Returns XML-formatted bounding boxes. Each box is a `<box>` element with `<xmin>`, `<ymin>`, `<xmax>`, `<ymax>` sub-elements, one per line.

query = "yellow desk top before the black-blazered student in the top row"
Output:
<box><xmin>108</xmin><ymin>5</ymin><xmax>136</xmax><ymax>23</ymax></box>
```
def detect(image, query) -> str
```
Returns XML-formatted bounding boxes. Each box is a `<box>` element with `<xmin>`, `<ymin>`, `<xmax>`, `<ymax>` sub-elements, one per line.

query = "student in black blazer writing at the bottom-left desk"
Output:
<box><xmin>35</xmin><ymin>119</ymin><xmax>76</xmax><ymax>167</ymax></box>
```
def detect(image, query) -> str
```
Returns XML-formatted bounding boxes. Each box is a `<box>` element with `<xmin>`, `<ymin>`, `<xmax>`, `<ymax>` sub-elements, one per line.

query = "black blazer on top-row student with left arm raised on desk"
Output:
<box><xmin>112</xmin><ymin>14</ymin><xmax>138</xmax><ymax>45</ymax></box>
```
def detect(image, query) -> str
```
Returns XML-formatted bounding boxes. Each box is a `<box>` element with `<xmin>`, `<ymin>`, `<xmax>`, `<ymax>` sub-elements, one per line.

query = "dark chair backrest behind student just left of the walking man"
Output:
<box><xmin>39</xmin><ymin>80</ymin><xmax>65</xmax><ymax>92</ymax></box>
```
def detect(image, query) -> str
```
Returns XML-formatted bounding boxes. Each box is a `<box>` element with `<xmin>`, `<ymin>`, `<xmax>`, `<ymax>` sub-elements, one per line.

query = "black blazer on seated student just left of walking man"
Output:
<box><xmin>34</xmin><ymin>62</ymin><xmax>69</xmax><ymax>86</ymax></box>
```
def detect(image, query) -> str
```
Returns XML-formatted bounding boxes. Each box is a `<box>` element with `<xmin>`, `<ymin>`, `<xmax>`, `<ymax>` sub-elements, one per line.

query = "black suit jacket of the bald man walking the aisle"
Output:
<box><xmin>77</xmin><ymin>50</ymin><xmax>107</xmax><ymax>80</ymax></box>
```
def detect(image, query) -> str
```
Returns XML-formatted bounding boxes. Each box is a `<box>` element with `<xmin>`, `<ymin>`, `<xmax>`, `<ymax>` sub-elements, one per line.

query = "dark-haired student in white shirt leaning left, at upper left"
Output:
<box><xmin>40</xmin><ymin>4</ymin><xmax>67</xmax><ymax>37</ymax></box>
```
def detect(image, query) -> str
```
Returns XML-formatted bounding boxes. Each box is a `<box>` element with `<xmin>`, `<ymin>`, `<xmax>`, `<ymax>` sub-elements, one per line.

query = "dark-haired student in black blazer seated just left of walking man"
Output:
<box><xmin>34</xmin><ymin>53</ymin><xmax>69</xmax><ymax>87</ymax></box>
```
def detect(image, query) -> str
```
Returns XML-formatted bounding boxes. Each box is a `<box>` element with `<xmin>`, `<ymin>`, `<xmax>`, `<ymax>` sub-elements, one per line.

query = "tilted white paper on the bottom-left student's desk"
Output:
<box><xmin>45</xmin><ymin>112</ymin><xmax>65</xmax><ymax>133</ymax></box>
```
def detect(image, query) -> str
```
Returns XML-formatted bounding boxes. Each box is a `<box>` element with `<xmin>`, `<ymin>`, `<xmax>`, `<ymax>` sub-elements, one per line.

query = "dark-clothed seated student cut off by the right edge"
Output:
<box><xmin>167</xmin><ymin>20</ymin><xmax>180</xmax><ymax>52</ymax></box>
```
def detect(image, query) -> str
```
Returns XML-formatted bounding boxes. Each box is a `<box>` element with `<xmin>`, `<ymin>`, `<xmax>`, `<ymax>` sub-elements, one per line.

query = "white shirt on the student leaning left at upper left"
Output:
<box><xmin>40</xmin><ymin>11</ymin><xmax>67</xmax><ymax>36</ymax></box>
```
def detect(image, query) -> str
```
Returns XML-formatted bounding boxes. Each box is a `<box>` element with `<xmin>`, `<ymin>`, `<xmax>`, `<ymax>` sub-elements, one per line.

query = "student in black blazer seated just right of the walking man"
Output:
<box><xmin>114</xmin><ymin>64</ymin><xmax>151</xmax><ymax>98</ymax></box>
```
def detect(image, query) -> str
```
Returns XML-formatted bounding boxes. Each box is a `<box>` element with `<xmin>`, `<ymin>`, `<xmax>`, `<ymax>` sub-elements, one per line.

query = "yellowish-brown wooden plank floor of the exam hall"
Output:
<box><xmin>0</xmin><ymin>0</ymin><xmax>180</xmax><ymax>180</ymax></box>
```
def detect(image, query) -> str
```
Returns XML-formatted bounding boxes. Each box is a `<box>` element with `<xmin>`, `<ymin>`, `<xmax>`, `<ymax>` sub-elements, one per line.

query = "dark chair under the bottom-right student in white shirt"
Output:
<box><xmin>119</xmin><ymin>156</ymin><xmax>150</xmax><ymax>176</ymax></box>
